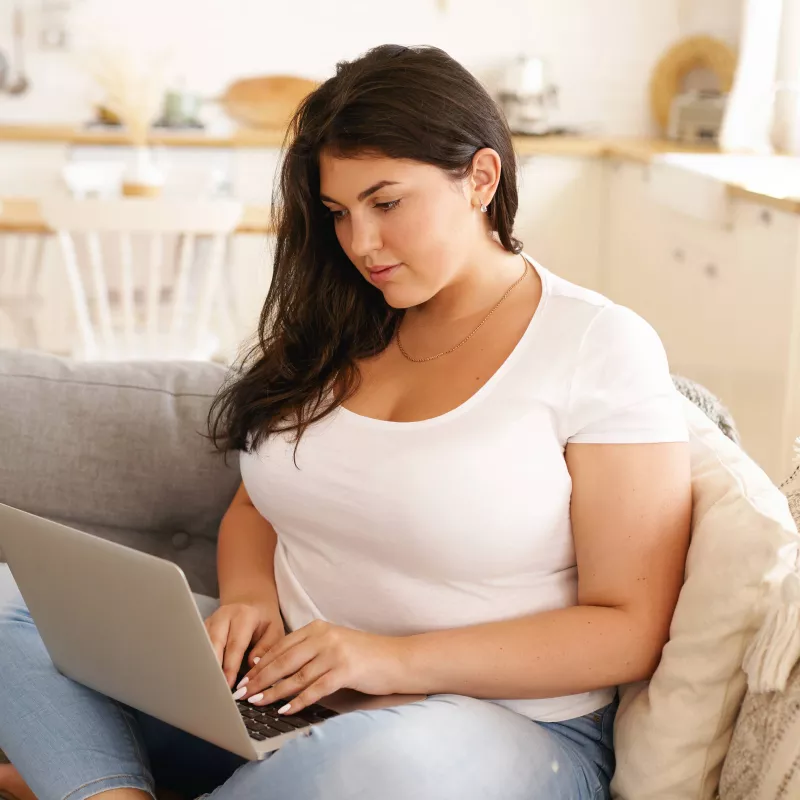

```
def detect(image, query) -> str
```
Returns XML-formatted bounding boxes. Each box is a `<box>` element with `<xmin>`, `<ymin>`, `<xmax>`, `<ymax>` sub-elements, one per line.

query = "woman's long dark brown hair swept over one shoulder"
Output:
<box><xmin>208</xmin><ymin>45</ymin><xmax>522</xmax><ymax>452</ymax></box>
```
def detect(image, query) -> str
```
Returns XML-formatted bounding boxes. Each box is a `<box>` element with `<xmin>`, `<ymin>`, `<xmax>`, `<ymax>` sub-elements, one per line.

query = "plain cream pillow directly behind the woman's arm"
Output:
<box><xmin>612</xmin><ymin>399</ymin><xmax>800</xmax><ymax>800</ymax></box>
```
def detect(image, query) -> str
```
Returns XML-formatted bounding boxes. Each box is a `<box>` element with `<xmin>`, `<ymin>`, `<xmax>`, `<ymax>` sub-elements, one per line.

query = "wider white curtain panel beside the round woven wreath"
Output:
<box><xmin>720</xmin><ymin>0</ymin><xmax>784</xmax><ymax>154</ymax></box>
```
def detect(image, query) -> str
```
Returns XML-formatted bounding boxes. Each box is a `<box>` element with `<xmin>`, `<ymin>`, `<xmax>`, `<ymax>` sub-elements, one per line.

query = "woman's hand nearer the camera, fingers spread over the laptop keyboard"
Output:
<box><xmin>234</xmin><ymin>620</ymin><xmax>405</xmax><ymax>714</ymax></box>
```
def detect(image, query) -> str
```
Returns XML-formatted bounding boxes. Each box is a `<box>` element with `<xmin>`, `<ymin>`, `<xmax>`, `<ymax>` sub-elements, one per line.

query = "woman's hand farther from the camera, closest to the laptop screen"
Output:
<box><xmin>205</xmin><ymin>600</ymin><xmax>285</xmax><ymax>689</ymax></box>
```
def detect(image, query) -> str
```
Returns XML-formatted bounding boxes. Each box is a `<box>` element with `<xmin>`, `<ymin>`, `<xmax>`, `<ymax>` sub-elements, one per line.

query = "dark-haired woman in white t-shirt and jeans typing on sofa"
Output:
<box><xmin>0</xmin><ymin>46</ymin><xmax>691</xmax><ymax>800</ymax></box>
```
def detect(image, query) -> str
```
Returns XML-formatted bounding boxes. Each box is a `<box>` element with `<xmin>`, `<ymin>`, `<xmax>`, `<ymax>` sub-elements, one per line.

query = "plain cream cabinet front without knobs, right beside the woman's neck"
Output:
<box><xmin>514</xmin><ymin>156</ymin><xmax>604</xmax><ymax>289</ymax></box>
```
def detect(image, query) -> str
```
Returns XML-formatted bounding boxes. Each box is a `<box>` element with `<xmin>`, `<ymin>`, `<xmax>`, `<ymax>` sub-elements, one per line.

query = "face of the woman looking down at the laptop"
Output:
<box><xmin>320</xmin><ymin>153</ymin><xmax>485</xmax><ymax>308</ymax></box>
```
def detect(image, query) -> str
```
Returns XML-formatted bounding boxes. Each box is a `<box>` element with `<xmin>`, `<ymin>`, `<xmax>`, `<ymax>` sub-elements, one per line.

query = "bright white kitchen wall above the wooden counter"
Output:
<box><xmin>0</xmin><ymin>0</ymin><xmax>741</xmax><ymax>134</ymax></box>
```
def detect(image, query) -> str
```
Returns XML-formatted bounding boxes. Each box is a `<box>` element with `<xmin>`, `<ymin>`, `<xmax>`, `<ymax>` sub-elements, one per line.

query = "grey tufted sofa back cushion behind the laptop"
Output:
<box><xmin>0</xmin><ymin>350</ymin><xmax>239</xmax><ymax>594</ymax></box>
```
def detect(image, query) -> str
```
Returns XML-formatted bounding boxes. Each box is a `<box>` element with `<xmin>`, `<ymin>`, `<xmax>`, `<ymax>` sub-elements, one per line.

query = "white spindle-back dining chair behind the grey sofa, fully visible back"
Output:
<box><xmin>41</xmin><ymin>198</ymin><xmax>243</xmax><ymax>360</ymax></box>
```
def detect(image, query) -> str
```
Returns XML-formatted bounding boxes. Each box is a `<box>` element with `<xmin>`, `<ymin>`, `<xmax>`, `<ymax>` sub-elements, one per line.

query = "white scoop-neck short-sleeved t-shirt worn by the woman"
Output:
<box><xmin>241</xmin><ymin>259</ymin><xmax>688</xmax><ymax>721</ymax></box>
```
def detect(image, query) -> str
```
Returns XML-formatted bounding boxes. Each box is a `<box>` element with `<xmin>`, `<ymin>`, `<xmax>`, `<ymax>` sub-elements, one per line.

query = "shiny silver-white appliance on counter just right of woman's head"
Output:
<box><xmin>497</xmin><ymin>55</ymin><xmax>558</xmax><ymax>135</ymax></box>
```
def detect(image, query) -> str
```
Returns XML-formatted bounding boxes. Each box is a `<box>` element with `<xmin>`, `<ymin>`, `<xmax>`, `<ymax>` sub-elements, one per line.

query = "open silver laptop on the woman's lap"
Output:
<box><xmin>0</xmin><ymin>503</ymin><xmax>422</xmax><ymax>760</ymax></box>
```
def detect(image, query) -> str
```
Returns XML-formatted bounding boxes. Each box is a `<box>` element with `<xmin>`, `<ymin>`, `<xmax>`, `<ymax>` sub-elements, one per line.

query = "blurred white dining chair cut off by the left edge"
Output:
<box><xmin>0</xmin><ymin>231</ymin><xmax>47</xmax><ymax>349</ymax></box>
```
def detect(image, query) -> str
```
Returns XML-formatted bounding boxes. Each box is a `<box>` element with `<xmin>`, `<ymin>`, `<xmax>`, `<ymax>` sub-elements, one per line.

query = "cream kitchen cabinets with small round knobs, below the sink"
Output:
<box><xmin>603</xmin><ymin>162</ymin><xmax>800</xmax><ymax>480</ymax></box>
